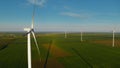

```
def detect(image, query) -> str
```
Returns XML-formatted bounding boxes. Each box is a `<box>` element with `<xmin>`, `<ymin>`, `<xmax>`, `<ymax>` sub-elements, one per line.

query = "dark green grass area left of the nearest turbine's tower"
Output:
<box><xmin>0</xmin><ymin>39</ymin><xmax>27</xmax><ymax>68</ymax></box>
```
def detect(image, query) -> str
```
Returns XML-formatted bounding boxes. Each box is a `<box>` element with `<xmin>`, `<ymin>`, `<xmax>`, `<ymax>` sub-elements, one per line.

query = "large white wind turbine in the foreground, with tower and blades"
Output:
<box><xmin>24</xmin><ymin>0</ymin><xmax>41</xmax><ymax>68</ymax></box>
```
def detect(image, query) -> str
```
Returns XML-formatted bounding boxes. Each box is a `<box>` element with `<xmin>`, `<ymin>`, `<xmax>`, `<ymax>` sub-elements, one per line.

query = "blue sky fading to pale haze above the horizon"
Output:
<box><xmin>0</xmin><ymin>0</ymin><xmax>120</xmax><ymax>32</ymax></box>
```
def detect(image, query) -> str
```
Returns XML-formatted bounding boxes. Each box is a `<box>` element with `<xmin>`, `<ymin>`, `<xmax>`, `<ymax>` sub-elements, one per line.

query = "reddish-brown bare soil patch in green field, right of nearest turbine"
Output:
<box><xmin>32</xmin><ymin>41</ymin><xmax>70</xmax><ymax>68</ymax></box>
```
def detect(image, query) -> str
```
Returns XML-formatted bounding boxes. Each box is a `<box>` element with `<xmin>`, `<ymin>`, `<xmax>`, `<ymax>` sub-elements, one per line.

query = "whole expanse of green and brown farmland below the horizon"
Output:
<box><xmin>0</xmin><ymin>33</ymin><xmax>120</xmax><ymax>68</ymax></box>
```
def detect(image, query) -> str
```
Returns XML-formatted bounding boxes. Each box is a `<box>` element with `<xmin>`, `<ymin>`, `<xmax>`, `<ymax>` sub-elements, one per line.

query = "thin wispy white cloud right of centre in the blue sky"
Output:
<box><xmin>60</xmin><ymin>12</ymin><xmax>87</xmax><ymax>18</ymax></box>
